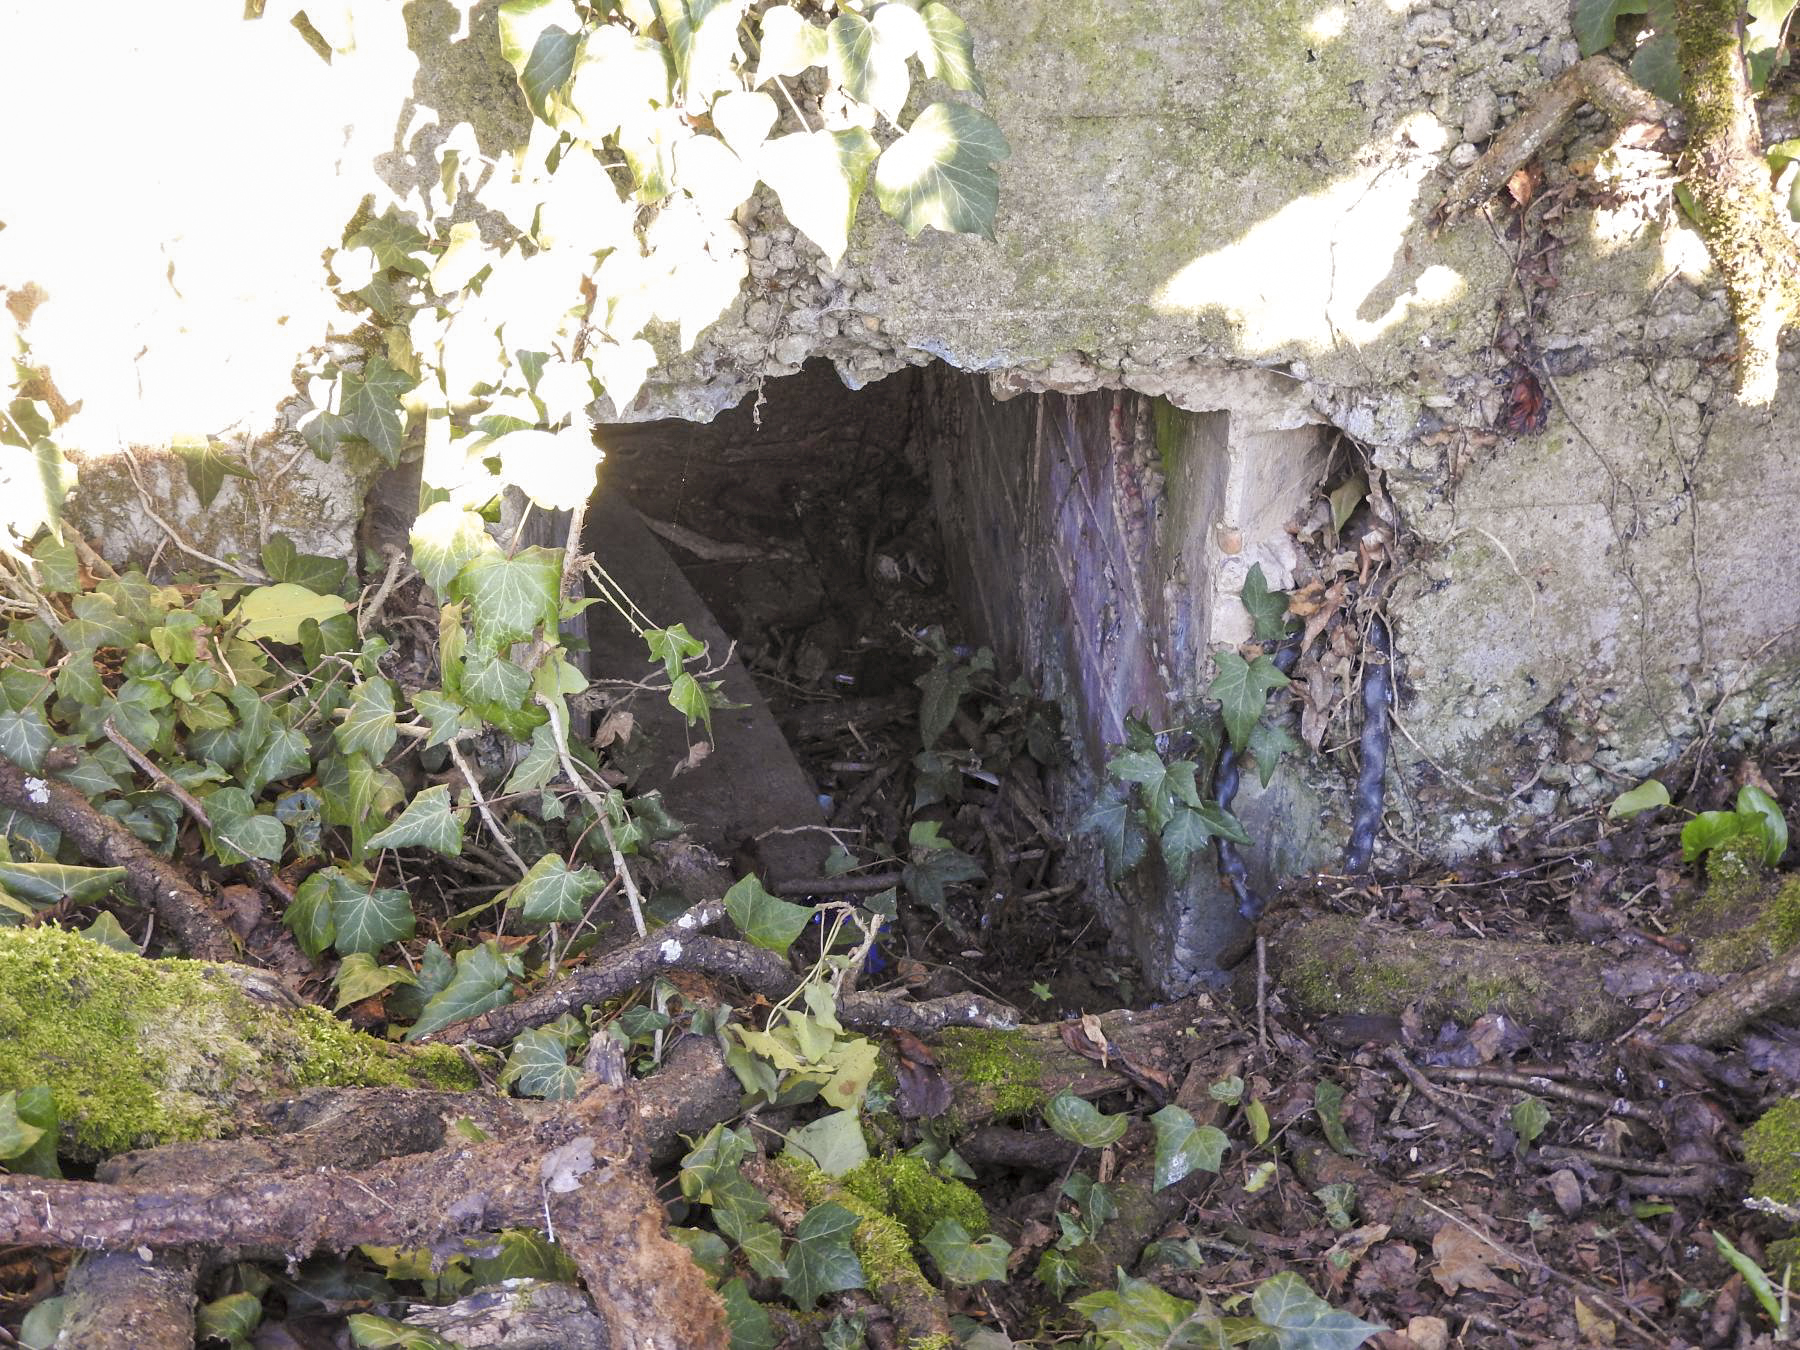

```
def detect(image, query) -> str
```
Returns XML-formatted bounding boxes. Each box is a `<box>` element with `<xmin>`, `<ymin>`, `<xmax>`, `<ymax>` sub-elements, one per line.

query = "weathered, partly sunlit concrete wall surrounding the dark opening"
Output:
<box><xmin>10</xmin><ymin>0</ymin><xmax>1800</xmax><ymax>993</ymax></box>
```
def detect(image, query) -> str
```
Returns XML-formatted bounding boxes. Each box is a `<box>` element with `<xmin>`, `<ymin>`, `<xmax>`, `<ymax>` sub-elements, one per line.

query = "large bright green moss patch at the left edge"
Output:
<box><xmin>0</xmin><ymin>927</ymin><xmax>475</xmax><ymax>1156</ymax></box>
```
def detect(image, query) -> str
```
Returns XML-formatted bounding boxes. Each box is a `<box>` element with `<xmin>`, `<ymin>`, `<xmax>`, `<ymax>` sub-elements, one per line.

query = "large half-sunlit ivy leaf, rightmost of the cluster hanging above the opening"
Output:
<box><xmin>875</xmin><ymin>103</ymin><xmax>1012</xmax><ymax>239</ymax></box>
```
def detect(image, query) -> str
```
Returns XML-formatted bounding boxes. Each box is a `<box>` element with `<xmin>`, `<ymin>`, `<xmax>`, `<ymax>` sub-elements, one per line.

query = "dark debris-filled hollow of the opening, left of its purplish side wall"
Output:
<box><xmin>587</xmin><ymin>362</ymin><xmax>1141</xmax><ymax>1008</ymax></box>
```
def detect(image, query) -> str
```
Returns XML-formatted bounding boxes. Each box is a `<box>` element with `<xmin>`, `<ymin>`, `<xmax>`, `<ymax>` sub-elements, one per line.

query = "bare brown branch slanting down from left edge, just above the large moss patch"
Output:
<box><xmin>0</xmin><ymin>756</ymin><xmax>243</xmax><ymax>961</ymax></box>
